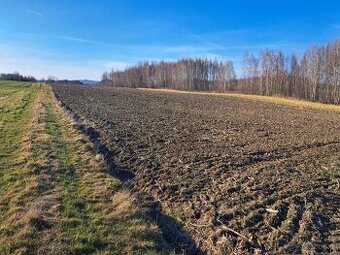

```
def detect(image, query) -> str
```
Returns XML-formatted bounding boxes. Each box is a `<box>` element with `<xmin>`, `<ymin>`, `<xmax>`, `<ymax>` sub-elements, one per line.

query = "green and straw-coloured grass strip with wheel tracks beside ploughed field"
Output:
<box><xmin>0</xmin><ymin>83</ymin><xmax>170</xmax><ymax>254</ymax></box>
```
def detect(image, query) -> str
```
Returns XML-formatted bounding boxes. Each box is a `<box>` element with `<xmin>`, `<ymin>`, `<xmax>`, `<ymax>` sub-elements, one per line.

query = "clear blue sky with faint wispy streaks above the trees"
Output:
<box><xmin>0</xmin><ymin>0</ymin><xmax>340</xmax><ymax>79</ymax></box>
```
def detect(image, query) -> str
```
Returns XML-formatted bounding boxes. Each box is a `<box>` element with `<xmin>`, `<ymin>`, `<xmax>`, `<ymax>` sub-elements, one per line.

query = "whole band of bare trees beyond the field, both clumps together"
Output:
<box><xmin>101</xmin><ymin>40</ymin><xmax>340</xmax><ymax>104</ymax></box>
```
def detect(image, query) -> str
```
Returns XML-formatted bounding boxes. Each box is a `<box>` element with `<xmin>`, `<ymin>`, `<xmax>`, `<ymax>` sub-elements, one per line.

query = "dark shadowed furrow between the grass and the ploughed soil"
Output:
<box><xmin>57</xmin><ymin>99</ymin><xmax>204</xmax><ymax>255</ymax></box>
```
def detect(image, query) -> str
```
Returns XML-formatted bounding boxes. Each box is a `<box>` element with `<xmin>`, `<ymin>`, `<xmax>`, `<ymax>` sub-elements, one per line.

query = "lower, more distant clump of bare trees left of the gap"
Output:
<box><xmin>102</xmin><ymin>58</ymin><xmax>236</xmax><ymax>91</ymax></box>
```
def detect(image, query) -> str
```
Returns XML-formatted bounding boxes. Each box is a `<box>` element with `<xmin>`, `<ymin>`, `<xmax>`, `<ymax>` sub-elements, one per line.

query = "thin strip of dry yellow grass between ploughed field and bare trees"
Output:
<box><xmin>140</xmin><ymin>88</ymin><xmax>340</xmax><ymax>112</ymax></box>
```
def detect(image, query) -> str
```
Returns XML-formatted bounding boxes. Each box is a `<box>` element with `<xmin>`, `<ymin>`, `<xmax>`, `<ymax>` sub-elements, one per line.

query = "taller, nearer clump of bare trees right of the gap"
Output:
<box><xmin>237</xmin><ymin>40</ymin><xmax>340</xmax><ymax>104</ymax></box>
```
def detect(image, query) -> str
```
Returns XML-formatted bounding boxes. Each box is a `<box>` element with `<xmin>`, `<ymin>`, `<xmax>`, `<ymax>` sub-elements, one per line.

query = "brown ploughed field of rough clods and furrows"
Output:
<box><xmin>54</xmin><ymin>86</ymin><xmax>340</xmax><ymax>254</ymax></box>
